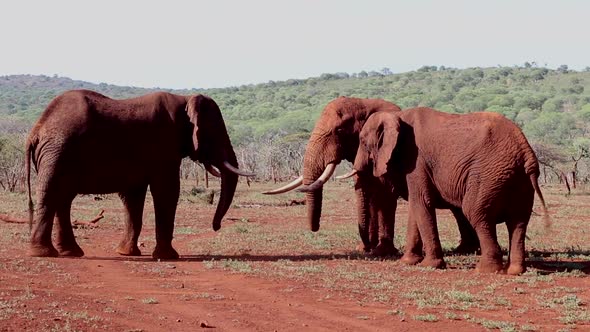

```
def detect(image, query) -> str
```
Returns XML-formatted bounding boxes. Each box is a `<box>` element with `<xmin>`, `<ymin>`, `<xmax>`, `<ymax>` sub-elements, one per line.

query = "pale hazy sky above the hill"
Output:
<box><xmin>0</xmin><ymin>0</ymin><xmax>590</xmax><ymax>88</ymax></box>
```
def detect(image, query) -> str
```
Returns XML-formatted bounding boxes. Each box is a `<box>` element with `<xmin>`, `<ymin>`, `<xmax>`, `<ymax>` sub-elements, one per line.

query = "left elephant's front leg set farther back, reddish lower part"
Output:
<box><xmin>117</xmin><ymin>185</ymin><xmax>147</xmax><ymax>256</ymax></box>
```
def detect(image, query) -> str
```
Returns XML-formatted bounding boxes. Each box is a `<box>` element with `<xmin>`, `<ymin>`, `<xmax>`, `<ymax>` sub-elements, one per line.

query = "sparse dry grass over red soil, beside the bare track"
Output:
<box><xmin>0</xmin><ymin>182</ymin><xmax>590</xmax><ymax>331</ymax></box>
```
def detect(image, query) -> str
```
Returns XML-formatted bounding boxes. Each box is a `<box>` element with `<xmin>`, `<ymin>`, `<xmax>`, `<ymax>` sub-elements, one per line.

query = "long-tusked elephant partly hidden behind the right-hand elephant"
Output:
<box><xmin>265</xmin><ymin>97</ymin><xmax>479</xmax><ymax>255</ymax></box>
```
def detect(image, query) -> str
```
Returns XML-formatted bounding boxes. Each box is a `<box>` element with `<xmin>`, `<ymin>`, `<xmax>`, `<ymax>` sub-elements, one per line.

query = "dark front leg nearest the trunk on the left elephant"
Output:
<box><xmin>150</xmin><ymin>172</ymin><xmax>180</xmax><ymax>259</ymax></box>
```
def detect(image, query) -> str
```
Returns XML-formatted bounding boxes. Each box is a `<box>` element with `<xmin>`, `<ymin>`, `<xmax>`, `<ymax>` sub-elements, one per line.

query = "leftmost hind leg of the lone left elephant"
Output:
<box><xmin>29</xmin><ymin>182</ymin><xmax>58</xmax><ymax>257</ymax></box>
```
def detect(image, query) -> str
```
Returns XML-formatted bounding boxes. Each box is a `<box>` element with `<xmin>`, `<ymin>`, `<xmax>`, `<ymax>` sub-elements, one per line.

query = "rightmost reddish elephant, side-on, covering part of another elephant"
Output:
<box><xmin>353</xmin><ymin>107</ymin><xmax>548</xmax><ymax>275</ymax></box>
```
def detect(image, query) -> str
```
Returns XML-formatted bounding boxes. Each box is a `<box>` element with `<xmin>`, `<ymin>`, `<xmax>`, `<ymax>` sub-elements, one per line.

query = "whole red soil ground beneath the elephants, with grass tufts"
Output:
<box><xmin>0</xmin><ymin>185</ymin><xmax>590</xmax><ymax>331</ymax></box>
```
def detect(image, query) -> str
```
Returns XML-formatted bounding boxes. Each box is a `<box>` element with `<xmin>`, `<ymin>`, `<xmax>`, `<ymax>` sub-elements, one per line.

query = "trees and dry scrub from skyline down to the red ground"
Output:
<box><xmin>0</xmin><ymin>62</ymin><xmax>590</xmax><ymax>190</ymax></box>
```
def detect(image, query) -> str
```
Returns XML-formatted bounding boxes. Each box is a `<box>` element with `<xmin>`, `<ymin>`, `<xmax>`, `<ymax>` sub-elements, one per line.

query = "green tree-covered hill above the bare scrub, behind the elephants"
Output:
<box><xmin>0</xmin><ymin>63</ymin><xmax>590</xmax><ymax>158</ymax></box>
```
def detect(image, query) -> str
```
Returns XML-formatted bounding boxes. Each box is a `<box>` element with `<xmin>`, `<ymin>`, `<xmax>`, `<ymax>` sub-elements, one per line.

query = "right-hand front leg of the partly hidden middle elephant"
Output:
<box><xmin>371</xmin><ymin>189</ymin><xmax>399</xmax><ymax>256</ymax></box>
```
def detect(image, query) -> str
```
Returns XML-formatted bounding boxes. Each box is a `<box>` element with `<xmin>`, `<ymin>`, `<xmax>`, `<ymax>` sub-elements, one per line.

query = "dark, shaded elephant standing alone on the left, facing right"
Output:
<box><xmin>25</xmin><ymin>90</ymin><xmax>252</xmax><ymax>259</ymax></box>
